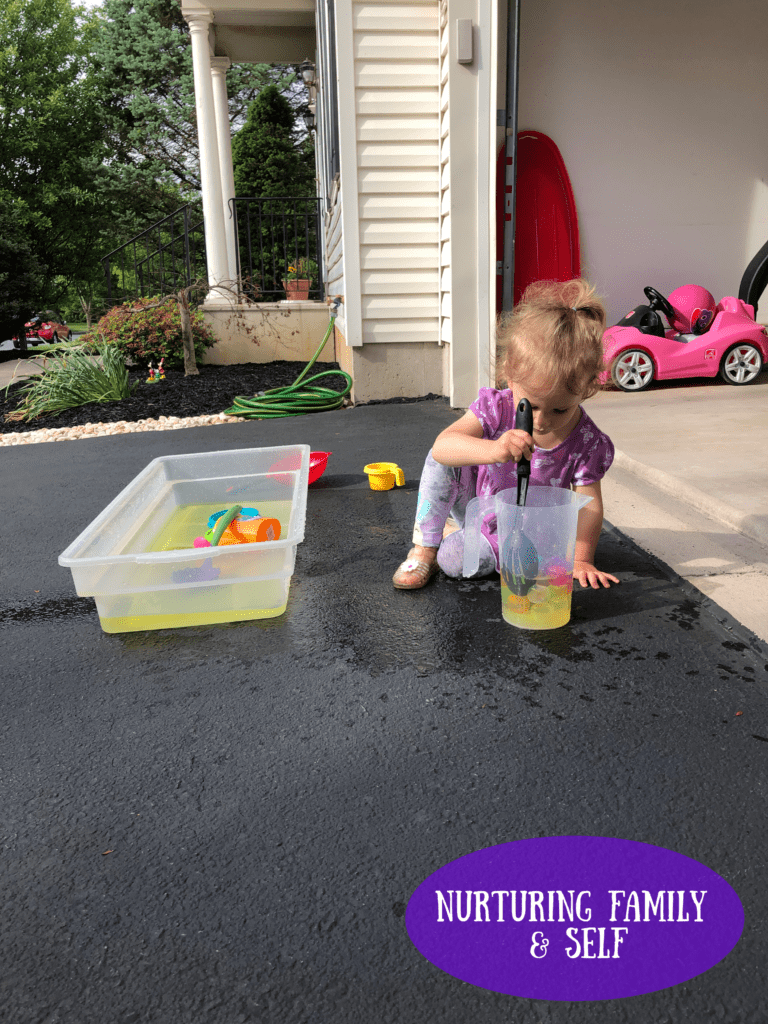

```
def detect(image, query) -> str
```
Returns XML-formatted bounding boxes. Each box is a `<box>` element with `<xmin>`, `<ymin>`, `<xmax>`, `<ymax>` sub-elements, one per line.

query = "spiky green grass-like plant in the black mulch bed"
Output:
<box><xmin>6</xmin><ymin>345</ymin><xmax>138</xmax><ymax>421</ymax></box>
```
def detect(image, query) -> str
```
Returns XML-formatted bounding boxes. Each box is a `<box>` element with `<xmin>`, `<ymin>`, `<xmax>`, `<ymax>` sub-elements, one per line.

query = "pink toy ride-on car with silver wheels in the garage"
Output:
<box><xmin>601</xmin><ymin>285</ymin><xmax>768</xmax><ymax>391</ymax></box>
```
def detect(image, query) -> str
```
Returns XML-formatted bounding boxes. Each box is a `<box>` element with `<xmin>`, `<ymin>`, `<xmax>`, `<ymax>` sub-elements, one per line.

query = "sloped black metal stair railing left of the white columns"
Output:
<box><xmin>101</xmin><ymin>203</ymin><xmax>207</xmax><ymax>305</ymax></box>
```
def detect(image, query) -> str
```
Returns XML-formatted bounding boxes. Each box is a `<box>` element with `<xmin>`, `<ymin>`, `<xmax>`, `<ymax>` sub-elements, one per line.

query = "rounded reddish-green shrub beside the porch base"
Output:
<box><xmin>92</xmin><ymin>298</ymin><xmax>216</xmax><ymax>370</ymax></box>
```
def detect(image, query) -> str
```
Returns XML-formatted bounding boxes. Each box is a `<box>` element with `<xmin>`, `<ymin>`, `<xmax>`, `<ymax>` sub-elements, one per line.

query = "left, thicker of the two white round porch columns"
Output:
<box><xmin>186</xmin><ymin>11</ymin><xmax>230</xmax><ymax>300</ymax></box>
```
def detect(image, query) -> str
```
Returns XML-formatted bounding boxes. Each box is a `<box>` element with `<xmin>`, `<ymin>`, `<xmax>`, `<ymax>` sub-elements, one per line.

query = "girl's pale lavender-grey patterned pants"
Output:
<box><xmin>413</xmin><ymin>452</ymin><xmax>497</xmax><ymax>578</ymax></box>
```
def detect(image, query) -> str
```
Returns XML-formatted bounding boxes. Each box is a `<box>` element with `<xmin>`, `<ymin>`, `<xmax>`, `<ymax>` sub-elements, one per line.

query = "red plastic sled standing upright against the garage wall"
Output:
<box><xmin>496</xmin><ymin>131</ymin><xmax>582</xmax><ymax>312</ymax></box>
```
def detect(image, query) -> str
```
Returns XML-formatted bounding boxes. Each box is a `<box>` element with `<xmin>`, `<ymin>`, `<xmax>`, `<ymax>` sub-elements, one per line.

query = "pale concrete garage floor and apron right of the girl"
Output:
<box><xmin>587</xmin><ymin>373</ymin><xmax>768</xmax><ymax>640</ymax></box>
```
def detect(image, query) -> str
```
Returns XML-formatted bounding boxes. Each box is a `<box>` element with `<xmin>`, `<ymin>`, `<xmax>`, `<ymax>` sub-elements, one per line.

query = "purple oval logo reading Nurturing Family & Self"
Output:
<box><xmin>406</xmin><ymin>836</ymin><xmax>744</xmax><ymax>1001</ymax></box>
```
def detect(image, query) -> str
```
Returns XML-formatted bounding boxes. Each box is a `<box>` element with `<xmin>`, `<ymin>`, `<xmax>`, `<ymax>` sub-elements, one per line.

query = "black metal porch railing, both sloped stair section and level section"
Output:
<box><xmin>101</xmin><ymin>197</ymin><xmax>325</xmax><ymax>306</ymax></box>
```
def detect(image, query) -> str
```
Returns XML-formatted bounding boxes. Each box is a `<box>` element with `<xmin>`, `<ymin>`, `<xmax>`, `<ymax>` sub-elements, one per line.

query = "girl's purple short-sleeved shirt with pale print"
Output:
<box><xmin>469</xmin><ymin>387</ymin><xmax>614</xmax><ymax>498</ymax></box>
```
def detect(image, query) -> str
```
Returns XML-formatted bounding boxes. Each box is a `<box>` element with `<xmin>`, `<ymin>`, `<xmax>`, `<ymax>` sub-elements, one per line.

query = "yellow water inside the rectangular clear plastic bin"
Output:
<box><xmin>96</xmin><ymin>499</ymin><xmax>291</xmax><ymax>633</ymax></box>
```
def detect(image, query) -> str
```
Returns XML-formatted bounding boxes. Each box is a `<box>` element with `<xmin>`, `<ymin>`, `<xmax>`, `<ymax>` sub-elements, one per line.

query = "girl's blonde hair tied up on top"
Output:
<box><xmin>496</xmin><ymin>278</ymin><xmax>605</xmax><ymax>398</ymax></box>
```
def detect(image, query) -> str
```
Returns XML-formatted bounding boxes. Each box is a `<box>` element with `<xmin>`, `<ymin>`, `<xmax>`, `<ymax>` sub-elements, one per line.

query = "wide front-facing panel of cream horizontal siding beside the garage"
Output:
<box><xmin>354</xmin><ymin>0</ymin><xmax>440</xmax><ymax>344</ymax></box>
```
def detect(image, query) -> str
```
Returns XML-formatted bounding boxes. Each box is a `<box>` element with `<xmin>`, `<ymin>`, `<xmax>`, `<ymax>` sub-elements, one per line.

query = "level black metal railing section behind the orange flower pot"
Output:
<box><xmin>229</xmin><ymin>196</ymin><xmax>326</xmax><ymax>302</ymax></box>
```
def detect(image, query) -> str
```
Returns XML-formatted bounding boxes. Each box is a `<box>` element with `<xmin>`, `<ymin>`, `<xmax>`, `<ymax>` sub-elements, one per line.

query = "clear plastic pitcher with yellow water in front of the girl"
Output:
<box><xmin>464</xmin><ymin>486</ymin><xmax>592</xmax><ymax>630</ymax></box>
